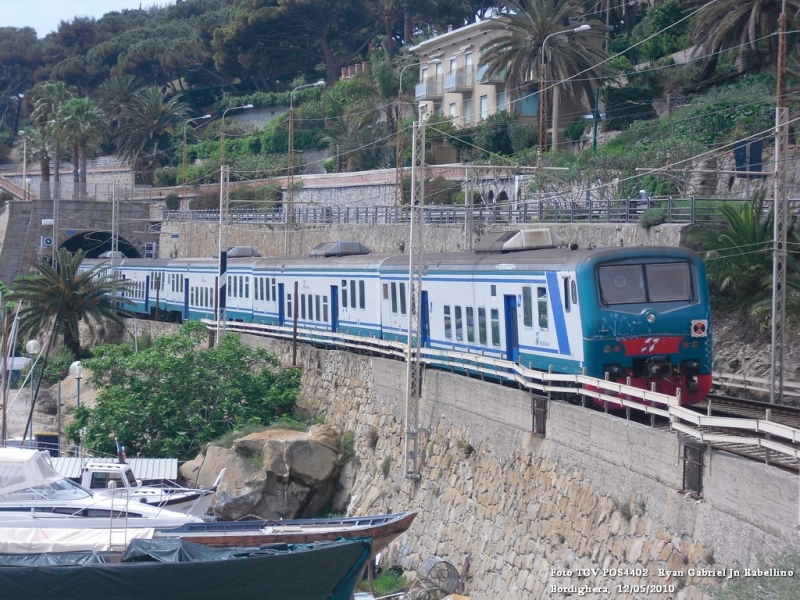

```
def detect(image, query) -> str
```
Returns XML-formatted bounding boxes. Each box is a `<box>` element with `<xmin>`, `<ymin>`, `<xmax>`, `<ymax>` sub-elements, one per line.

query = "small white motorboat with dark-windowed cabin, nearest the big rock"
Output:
<box><xmin>81</xmin><ymin>462</ymin><xmax>225</xmax><ymax>520</ymax></box>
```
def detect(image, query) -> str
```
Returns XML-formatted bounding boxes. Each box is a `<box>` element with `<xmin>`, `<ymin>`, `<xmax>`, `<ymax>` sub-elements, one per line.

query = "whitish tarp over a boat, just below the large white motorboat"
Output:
<box><xmin>0</xmin><ymin>527</ymin><xmax>154</xmax><ymax>554</ymax></box>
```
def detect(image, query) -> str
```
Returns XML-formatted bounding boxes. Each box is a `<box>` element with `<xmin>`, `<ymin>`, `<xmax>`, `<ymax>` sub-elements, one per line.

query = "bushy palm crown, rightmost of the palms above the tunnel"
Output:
<box><xmin>116</xmin><ymin>87</ymin><xmax>190</xmax><ymax>180</ymax></box>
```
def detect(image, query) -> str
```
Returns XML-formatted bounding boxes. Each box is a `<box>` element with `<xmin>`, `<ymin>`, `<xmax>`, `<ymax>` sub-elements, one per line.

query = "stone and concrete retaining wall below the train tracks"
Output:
<box><xmin>244</xmin><ymin>336</ymin><xmax>798</xmax><ymax>599</ymax></box>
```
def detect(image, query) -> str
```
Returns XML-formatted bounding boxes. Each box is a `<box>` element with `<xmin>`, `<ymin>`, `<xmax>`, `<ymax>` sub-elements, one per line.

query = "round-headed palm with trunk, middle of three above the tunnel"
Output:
<box><xmin>58</xmin><ymin>98</ymin><xmax>107</xmax><ymax>198</ymax></box>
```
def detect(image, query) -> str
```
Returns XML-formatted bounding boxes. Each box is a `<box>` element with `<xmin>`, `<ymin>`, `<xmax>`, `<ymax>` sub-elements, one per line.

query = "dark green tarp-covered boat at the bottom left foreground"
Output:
<box><xmin>0</xmin><ymin>538</ymin><xmax>372</xmax><ymax>600</ymax></box>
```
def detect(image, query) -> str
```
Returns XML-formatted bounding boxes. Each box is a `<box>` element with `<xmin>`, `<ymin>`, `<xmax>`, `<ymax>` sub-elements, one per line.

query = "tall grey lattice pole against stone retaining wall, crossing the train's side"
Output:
<box><xmin>405</xmin><ymin>121</ymin><xmax>427</xmax><ymax>479</ymax></box>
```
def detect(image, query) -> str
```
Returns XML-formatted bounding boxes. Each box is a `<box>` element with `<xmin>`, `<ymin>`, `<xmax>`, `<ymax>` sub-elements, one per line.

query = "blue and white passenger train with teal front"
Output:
<box><xmin>84</xmin><ymin>229</ymin><xmax>712</xmax><ymax>405</ymax></box>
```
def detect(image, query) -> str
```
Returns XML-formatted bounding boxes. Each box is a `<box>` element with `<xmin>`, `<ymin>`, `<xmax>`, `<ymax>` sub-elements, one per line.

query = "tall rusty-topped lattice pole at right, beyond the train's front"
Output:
<box><xmin>769</xmin><ymin>0</ymin><xmax>789</xmax><ymax>404</ymax></box>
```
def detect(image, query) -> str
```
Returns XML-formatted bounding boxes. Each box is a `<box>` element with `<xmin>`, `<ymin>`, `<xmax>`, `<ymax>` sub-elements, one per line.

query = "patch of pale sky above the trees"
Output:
<box><xmin>5</xmin><ymin>0</ymin><xmax>174</xmax><ymax>38</ymax></box>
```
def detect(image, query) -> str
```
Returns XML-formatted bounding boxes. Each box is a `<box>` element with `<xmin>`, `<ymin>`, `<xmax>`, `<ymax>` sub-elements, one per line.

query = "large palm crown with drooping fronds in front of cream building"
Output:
<box><xmin>478</xmin><ymin>0</ymin><xmax>603</xmax><ymax>149</ymax></box>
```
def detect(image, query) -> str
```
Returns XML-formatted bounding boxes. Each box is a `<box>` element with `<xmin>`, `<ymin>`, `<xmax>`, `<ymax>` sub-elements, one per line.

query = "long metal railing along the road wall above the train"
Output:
<box><xmin>163</xmin><ymin>196</ymin><xmax>784</xmax><ymax>226</ymax></box>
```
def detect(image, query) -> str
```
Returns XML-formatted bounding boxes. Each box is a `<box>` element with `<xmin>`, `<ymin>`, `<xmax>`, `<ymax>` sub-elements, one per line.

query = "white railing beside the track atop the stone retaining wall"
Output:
<box><xmin>209</xmin><ymin>320</ymin><xmax>800</xmax><ymax>472</ymax></box>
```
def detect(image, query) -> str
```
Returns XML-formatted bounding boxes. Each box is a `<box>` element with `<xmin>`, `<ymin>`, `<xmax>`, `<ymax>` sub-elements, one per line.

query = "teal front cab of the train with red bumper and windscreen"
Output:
<box><xmin>581</xmin><ymin>248</ymin><xmax>711</xmax><ymax>408</ymax></box>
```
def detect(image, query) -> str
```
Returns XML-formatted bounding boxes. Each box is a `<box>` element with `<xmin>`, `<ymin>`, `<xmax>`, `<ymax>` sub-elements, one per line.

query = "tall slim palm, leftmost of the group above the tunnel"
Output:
<box><xmin>31</xmin><ymin>81</ymin><xmax>75</xmax><ymax>200</ymax></box>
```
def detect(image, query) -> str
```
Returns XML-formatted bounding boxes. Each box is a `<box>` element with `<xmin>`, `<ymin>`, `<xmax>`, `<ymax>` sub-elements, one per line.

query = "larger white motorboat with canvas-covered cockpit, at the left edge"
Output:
<box><xmin>0</xmin><ymin>448</ymin><xmax>202</xmax><ymax>529</ymax></box>
